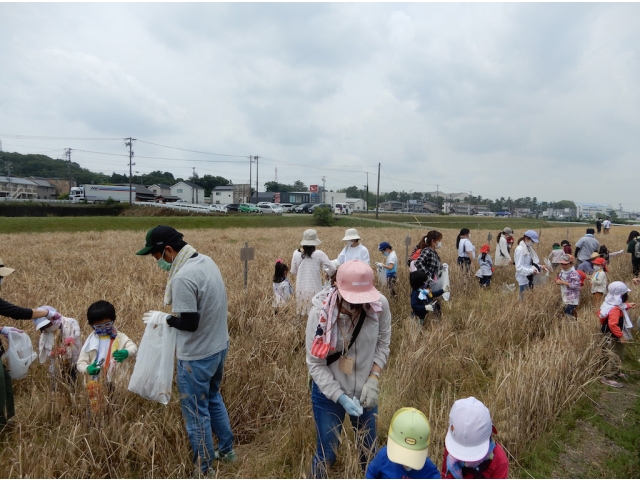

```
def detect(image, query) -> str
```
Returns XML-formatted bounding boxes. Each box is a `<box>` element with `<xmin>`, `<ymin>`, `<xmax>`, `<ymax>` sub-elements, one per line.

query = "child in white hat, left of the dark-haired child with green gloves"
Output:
<box><xmin>33</xmin><ymin>305</ymin><xmax>82</xmax><ymax>382</ymax></box>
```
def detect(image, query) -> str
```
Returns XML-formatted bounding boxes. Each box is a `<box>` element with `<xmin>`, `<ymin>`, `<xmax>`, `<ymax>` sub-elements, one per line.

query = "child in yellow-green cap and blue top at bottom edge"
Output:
<box><xmin>365</xmin><ymin>408</ymin><xmax>440</xmax><ymax>478</ymax></box>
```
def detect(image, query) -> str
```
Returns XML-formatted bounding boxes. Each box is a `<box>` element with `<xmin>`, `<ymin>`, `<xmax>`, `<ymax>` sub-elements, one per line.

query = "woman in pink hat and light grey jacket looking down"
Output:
<box><xmin>306</xmin><ymin>260</ymin><xmax>391</xmax><ymax>478</ymax></box>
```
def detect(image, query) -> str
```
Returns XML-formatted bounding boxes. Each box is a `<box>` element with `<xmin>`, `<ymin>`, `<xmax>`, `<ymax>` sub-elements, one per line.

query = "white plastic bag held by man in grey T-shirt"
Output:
<box><xmin>129</xmin><ymin>312</ymin><xmax>176</xmax><ymax>405</ymax></box>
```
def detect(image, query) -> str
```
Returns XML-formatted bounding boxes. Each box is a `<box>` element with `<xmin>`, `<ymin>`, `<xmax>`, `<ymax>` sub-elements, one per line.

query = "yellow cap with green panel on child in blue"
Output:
<box><xmin>387</xmin><ymin>407</ymin><xmax>431</xmax><ymax>470</ymax></box>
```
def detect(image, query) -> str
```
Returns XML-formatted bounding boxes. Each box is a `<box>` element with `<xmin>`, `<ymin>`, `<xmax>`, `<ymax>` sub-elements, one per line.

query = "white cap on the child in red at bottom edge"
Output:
<box><xmin>444</xmin><ymin>397</ymin><xmax>493</xmax><ymax>462</ymax></box>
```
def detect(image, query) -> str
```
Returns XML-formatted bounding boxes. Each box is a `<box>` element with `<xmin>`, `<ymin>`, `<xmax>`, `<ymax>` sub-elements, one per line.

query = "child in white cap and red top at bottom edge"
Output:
<box><xmin>442</xmin><ymin>397</ymin><xmax>509</xmax><ymax>478</ymax></box>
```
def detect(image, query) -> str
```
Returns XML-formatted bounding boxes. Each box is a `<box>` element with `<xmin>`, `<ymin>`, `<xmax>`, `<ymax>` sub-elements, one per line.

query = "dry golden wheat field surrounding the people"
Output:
<box><xmin>0</xmin><ymin>227</ymin><xmax>631</xmax><ymax>478</ymax></box>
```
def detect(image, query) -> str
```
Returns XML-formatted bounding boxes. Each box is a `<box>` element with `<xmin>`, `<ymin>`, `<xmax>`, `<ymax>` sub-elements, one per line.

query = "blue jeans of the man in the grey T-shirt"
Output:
<box><xmin>178</xmin><ymin>344</ymin><xmax>233</xmax><ymax>473</ymax></box>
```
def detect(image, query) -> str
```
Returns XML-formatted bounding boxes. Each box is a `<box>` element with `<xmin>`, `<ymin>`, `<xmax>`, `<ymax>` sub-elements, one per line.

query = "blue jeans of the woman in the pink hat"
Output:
<box><xmin>311</xmin><ymin>382</ymin><xmax>378</xmax><ymax>478</ymax></box>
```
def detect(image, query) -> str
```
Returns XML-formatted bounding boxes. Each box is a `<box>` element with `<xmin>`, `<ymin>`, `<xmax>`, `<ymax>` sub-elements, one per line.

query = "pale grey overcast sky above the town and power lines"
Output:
<box><xmin>0</xmin><ymin>3</ymin><xmax>640</xmax><ymax>210</ymax></box>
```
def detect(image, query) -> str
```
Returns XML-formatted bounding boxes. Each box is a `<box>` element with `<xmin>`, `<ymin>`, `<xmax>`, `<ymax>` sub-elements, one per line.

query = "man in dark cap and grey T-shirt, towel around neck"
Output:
<box><xmin>136</xmin><ymin>225</ymin><xmax>236</xmax><ymax>475</ymax></box>
